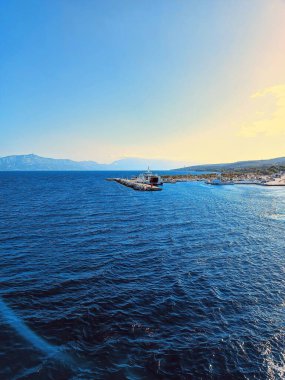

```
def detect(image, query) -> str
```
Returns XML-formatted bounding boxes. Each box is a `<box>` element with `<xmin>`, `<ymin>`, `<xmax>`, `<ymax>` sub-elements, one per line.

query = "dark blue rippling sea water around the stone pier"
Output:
<box><xmin>0</xmin><ymin>172</ymin><xmax>285</xmax><ymax>380</ymax></box>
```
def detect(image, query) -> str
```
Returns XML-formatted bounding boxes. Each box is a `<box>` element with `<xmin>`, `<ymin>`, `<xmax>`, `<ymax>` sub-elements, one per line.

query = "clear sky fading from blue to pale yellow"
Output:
<box><xmin>0</xmin><ymin>0</ymin><xmax>285</xmax><ymax>164</ymax></box>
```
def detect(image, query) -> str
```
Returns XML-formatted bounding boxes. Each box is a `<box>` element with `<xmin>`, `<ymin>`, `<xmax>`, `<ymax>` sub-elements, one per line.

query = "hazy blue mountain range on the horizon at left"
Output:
<box><xmin>0</xmin><ymin>154</ymin><xmax>181</xmax><ymax>171</ymax></box>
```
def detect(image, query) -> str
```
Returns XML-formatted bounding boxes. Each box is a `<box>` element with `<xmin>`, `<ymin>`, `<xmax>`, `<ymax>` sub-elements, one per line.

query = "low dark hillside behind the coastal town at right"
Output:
<box><xmin>177</xmin><ymin>157</ymin><xmax>285</xmax><ymax>171</ymax></box>
